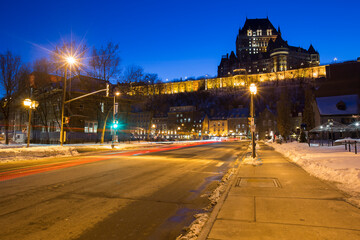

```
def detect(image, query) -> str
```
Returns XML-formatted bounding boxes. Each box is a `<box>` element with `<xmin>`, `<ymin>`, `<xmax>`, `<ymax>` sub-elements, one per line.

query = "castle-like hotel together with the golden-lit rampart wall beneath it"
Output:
<box><xmin>130</xmin><ymin>18</ymin><xmax>326</xmax><ymax>95</ymax></box>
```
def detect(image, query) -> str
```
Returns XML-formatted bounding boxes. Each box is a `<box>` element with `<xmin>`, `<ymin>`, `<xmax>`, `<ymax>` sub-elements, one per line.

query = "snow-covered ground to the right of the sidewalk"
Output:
<box><xmin>267</xmin><ymin>142</ymin><xmax>360</xmax><ymax>206</ymax></box>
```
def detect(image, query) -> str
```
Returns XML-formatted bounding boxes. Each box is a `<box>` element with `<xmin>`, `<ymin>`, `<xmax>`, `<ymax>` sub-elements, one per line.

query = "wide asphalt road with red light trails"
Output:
<box><xmin>0</xmin><ymin>142</ymin><xmax>247</xmax><ymax>240</ymax></box>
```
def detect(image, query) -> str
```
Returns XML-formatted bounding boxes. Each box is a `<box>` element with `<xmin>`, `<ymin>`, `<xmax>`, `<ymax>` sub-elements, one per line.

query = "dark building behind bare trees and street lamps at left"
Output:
<box><xmin>10</xmin><ymin>72</ymin><xmax>113</xmax><ymax>143</ymax></box>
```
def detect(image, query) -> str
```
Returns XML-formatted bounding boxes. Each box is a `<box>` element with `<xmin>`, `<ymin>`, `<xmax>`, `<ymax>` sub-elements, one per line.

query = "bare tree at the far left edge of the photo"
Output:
<box><xmin>0</xmin><ymin>51</ymin><xmax>21</xmax><ymax>144</ymax></box>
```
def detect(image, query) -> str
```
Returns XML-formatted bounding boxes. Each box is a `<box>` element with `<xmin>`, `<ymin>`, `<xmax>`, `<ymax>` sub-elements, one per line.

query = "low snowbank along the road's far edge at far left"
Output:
<box><xmin>0</xmin><ymin>146</ymin><xmax>78</xmax><ymax>163</ymax></box>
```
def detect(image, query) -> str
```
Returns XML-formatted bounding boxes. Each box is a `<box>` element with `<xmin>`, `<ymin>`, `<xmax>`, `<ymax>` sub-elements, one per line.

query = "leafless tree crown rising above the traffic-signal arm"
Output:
<box><xmin>89</xmin><ymin>42</ymin><xmax>121</xmax><ymax>81</ymax></box>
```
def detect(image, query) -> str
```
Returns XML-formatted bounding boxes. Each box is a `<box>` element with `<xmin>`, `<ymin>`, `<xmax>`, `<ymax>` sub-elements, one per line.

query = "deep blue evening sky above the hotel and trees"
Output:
<box><xmin>0</xmin><ymin>0</ymin><xmax>360</xmax><ymax>80</ymax></box>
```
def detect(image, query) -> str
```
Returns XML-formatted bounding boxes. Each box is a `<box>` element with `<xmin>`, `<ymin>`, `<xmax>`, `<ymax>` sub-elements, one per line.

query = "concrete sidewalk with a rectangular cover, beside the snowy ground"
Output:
<box><xmin>202</xmin><ymin>144</ymin><xmax>360</xmax><ymax>240</ymax></box>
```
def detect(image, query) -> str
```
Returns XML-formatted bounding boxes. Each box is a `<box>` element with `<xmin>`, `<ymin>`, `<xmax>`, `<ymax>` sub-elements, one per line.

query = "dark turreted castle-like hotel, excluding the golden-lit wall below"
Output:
<box><xmin>218</xmin><ymin>18</ymin><xmax>320</xmax><ymax>77</ymax></box>
